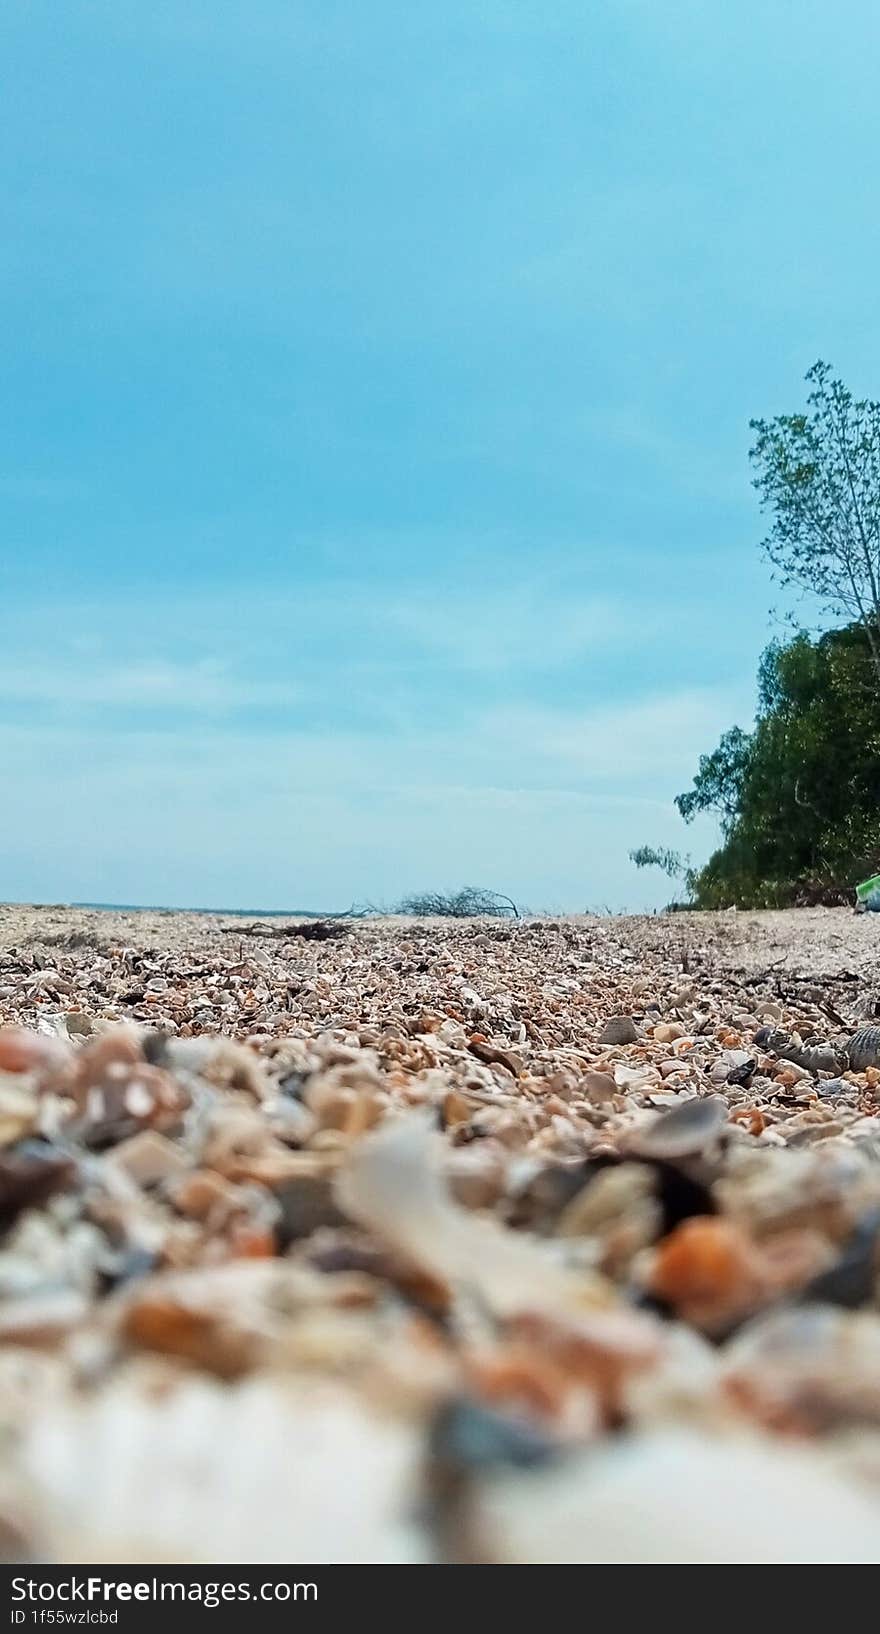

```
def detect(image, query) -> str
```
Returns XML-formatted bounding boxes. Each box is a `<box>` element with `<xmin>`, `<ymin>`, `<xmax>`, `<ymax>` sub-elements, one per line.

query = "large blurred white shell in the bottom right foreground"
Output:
<box><xmin>469</xmin><ymin>1425</ymin><xmax>880</xmax><ymax>1565</ymax></box>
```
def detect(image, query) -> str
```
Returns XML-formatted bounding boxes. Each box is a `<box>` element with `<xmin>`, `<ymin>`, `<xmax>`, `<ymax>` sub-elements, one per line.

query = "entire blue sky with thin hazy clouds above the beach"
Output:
<box><xmin>0</xmin><ymin>0</ymin><xmax>880</xmax><ymax>910</ymax></box>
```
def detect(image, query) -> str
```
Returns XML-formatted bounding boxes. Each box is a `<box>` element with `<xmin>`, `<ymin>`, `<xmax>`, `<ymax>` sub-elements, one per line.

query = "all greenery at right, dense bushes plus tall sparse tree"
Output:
<box><xmin>630</xmin><ymin>363</ymin><xmax>880</xmax><ymax>909</ymax></box>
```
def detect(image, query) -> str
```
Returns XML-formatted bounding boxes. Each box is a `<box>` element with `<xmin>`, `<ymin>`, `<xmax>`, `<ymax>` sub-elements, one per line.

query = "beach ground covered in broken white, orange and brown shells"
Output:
<box><xmin>0</xmin><ymin>907</ymin><xmax>880</xmax><ymax>1564</ymax></box>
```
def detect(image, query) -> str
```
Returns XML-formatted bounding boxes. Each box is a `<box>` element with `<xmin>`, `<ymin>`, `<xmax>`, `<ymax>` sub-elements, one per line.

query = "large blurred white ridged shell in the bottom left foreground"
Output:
<box><xmin>16</xmin><ymin>1373</ymin><xmax>428</xmax><ymax>1565</ymax></box>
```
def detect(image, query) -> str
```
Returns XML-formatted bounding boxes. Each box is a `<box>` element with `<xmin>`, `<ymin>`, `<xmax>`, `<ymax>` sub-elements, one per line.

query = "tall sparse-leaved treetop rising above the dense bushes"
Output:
<box><xmin>749</xmin><ymin>361</ymin><xmax>880</xmax><ymax>686</ymax></box>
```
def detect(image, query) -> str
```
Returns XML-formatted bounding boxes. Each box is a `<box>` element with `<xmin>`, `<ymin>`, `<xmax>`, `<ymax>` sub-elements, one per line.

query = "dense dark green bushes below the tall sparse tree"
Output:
<box><xmin>678</xmin><ymin>624</ymin><xmax>880</xmax><ymax>907</ymax></box>
